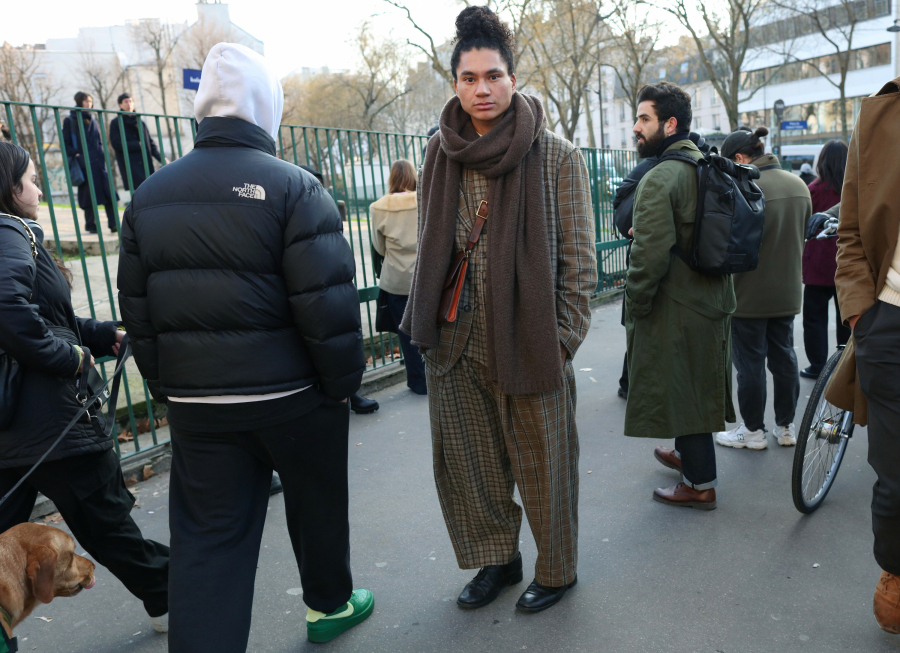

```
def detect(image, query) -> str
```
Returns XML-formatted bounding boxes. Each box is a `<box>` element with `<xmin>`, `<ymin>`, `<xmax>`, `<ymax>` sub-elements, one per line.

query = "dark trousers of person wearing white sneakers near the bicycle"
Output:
<box><xmin>731</xmin><ymin>316</ymin><xmax>800</xmax><ymax>431</ymax></box>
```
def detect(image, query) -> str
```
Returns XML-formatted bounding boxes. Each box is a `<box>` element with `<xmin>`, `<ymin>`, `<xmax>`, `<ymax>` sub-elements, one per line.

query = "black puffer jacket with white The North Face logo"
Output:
<box><xmin>119</xmin><ymin>117</ymin><xmax>365</xmax><ymax>399</ymax></box>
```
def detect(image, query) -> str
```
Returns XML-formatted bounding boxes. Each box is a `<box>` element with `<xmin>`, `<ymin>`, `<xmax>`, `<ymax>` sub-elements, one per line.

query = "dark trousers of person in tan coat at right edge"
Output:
<box><xmin>854</xmin><ymin>302</ymin><xmax>900</xmax><ymax>576</ymax></box>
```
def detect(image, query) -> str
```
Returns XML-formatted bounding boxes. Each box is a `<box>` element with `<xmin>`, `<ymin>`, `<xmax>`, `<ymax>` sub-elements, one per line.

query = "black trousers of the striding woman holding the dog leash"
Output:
<box><xmin>0</xmin><ymin>449</ymin><xmax>169</xmax><ymax>617</ymax></box>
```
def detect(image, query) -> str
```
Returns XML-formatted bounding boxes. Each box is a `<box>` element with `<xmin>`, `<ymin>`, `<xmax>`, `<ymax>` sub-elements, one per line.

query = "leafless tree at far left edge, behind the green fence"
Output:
<box><xmin>0</xmin><ymin>43</ymin><xmax>60</xmax><ymax>185</ymax></box>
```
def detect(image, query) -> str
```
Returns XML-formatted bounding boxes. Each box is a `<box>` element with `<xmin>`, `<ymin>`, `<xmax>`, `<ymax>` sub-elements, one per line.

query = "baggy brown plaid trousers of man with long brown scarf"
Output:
<box><xmin>426</xmin><ymin>354</ymin><xmax>578</xmax><ymax>587</ymax></box>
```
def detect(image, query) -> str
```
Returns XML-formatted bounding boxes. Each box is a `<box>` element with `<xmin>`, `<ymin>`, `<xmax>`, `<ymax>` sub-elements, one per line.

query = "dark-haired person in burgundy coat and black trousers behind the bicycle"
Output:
<box><xmin>800</xmin><ymin>140</ymin><xmax>850</xmax><ymax>379</ymax></box>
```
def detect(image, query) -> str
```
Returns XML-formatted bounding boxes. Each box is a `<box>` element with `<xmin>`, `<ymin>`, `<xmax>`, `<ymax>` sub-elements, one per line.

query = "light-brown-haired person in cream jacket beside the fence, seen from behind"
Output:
<box><xmin>369</xmin><ymin>159</ymin><xmax>428</xmax><ymax>395</ymax></box>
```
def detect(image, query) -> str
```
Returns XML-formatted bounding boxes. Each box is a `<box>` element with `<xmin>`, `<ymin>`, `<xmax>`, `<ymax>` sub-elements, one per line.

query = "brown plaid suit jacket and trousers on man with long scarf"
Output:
<box><xmin>425</xmin><ymin>132</ymin><xmax>597</xmax><ymax>587</ymax></box>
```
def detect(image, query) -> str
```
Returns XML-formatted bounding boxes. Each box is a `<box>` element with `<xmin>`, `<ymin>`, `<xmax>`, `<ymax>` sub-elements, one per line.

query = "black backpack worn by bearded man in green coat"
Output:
<box><xmin>659</xmin><ymin>150</ymin><xmax>766</xmax><ymax>275</ymax></box>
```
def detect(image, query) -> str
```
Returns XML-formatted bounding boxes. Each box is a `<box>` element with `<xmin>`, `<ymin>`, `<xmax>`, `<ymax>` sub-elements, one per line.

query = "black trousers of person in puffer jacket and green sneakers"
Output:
<box><xmin>169</xmin><ymin>400</ymin><xmax>353</xmax><ymax>653</ymax></box>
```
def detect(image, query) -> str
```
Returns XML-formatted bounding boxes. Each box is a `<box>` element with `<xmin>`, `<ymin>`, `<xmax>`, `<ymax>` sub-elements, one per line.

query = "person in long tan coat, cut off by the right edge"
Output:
<box><xmin>825</xmin><ymin>77</ymin><xmax>900</xmax><ymax>634</ymax></box>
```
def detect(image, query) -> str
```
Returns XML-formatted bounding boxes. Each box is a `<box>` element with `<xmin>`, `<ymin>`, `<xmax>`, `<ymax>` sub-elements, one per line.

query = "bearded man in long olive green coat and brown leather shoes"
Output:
<box><xmin>625</xmin><ymin>82</ymin><xmax>736</xmax><ymax>510</ymax></box>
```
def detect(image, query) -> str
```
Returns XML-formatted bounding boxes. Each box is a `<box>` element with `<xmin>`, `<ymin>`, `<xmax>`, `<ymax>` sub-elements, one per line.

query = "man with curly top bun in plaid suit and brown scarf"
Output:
<box><xmin>400</xmin><ymin>7</ymin><xmax>597</xmax><ymax>612</ymax></box>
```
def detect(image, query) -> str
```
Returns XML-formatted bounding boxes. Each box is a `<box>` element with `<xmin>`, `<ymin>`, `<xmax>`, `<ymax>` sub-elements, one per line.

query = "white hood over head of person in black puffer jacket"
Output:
<box><xmin>194</xmin><ymin>43</ymin><xmax>284</xmax><ymax>141</ymax></box>
